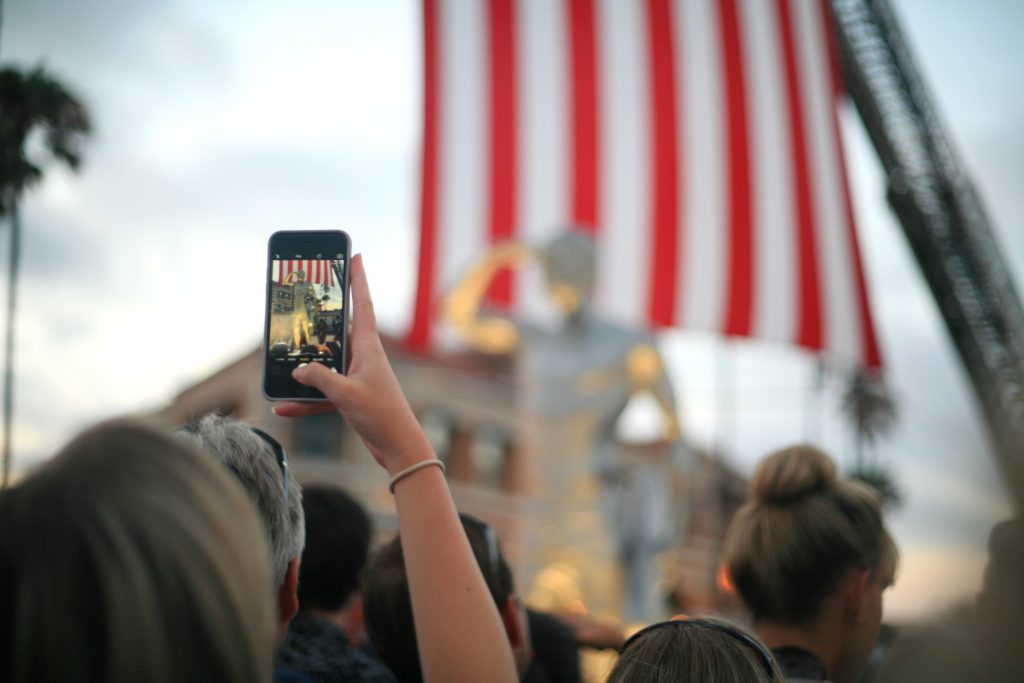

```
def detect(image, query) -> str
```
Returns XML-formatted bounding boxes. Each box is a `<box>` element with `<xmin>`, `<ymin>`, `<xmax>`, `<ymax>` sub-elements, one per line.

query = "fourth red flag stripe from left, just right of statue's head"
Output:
<box><xmin>646</xmin><ymin>0</ymin><xmax>679</xmax><ymax>326</ymax></box>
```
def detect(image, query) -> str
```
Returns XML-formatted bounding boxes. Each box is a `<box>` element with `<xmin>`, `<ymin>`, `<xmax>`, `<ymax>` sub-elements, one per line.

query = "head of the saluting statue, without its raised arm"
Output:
<box><xmin>540</xmin><ymin>226</ymin><xmax>596</xmax><ymax>314</ymax></box>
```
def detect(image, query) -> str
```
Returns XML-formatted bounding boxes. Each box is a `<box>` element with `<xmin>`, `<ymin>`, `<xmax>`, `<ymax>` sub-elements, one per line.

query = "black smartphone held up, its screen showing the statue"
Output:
<box><xmin>263</xmin><ymin>230</ymin><xmax>351</xmax><ymax>400</ymax></box>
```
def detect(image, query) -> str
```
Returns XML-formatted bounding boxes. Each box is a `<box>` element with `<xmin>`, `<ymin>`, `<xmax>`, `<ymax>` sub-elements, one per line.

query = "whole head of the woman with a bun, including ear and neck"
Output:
<box><xmin>725</xmin><ymin>445</ymin><xmax>897</xmax><ymax>677</ymax></box>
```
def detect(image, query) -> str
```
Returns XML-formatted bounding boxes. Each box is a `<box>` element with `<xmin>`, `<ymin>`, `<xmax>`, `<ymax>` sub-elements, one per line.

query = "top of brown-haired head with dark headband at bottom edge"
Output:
<box><xmin>608</xmin><ymin>618</ymin><xmax>784</xmax><ymax>683</ymax></box>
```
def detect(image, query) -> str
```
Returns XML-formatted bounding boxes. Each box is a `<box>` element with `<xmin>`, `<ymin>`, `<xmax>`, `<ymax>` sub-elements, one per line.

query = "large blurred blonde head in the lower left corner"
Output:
<box><xmin>0</xmin><ymin>421</ymin><xmax>274</xmax><ymax>682</ymax></box>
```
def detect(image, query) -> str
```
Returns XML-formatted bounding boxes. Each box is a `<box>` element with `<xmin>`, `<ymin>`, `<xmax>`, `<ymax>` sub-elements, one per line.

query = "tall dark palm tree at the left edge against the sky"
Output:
<box><xmin>0</xmin><ymin>66</ymin><xmax>91</xmax><ymax>486</ymax></box>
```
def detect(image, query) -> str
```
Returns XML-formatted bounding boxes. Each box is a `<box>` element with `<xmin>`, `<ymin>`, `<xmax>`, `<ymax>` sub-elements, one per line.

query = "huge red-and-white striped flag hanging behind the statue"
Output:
<box><xmin>410</xmin><ymin>0</ymin><xmax>881</xmax><ymax>368</ymax></box>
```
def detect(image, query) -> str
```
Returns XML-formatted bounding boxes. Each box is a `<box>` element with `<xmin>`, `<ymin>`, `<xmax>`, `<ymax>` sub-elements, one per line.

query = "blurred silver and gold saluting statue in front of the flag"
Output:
<box><xmin>443</xmin><ymin>232</ymin><xmax>680</xmax><ymax>620</ymax></box>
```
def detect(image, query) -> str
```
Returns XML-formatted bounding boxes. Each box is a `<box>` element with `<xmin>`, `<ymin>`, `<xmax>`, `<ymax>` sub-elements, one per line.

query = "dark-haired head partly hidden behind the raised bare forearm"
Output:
<box><xmin>362</xmin><ymin>514</ymin><xmax>530</xmax><ymax>683</ymax></box>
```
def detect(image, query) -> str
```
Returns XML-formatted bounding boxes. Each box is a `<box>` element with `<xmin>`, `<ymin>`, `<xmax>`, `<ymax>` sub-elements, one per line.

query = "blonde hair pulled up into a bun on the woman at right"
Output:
<box><xmin>725</xmin><ymin>445</ymin><xmax>896</xmax><ymax>624</ymax></box>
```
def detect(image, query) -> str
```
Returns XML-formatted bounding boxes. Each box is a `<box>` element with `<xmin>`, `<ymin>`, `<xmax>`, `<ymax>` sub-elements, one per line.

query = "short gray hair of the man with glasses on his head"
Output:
<box><xmin>184</xmin><ymin>413</ymin><xmax>306</xmax><ymax>588</ymax></box>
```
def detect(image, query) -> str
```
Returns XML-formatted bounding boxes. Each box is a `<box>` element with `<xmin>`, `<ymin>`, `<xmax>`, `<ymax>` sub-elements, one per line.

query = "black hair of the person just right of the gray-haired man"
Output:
<box><xmin>299</xmin><ymin>485</ymin><xmax>373</xmax><ymax>611</ymax></box>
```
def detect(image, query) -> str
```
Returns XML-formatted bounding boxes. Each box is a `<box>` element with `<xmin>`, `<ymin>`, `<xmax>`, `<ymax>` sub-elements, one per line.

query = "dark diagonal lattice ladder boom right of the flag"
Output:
<box><xmin>830</xmin><ymin>0</ymin><xmax>1024</xmax><ymax>509</ymax></box>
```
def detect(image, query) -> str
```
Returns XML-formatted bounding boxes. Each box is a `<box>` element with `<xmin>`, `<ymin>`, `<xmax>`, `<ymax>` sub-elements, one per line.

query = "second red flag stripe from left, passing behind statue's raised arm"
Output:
<box><xmin>487</xmin><ymin>0</ymin><xmax>517</xmax><ymax>309</ymax></box>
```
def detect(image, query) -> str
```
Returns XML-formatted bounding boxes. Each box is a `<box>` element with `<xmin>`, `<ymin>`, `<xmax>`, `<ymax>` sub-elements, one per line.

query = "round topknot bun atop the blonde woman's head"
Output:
<box><xmin>751</xmin><ymin>445</ymin><xmax>836</xmax><ymax>504</ymax></box>
